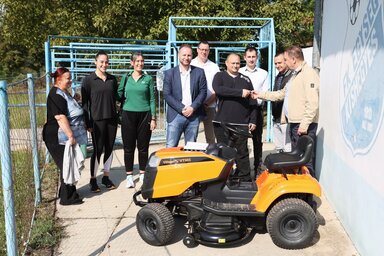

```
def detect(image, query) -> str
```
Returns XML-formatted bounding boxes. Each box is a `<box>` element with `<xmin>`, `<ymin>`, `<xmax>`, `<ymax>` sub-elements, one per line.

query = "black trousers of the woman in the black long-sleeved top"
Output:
<box><xmin>91</xmin><ymin>118</ymin><xmax>117</xmax><ymax>177</ymax></box>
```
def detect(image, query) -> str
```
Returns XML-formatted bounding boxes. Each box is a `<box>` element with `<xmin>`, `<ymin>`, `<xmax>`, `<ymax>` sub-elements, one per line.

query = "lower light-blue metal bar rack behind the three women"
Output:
<box><xmin>45</xmin><ymin>36</ymin><xmax>167</xmax><ymax>144</ymax></box>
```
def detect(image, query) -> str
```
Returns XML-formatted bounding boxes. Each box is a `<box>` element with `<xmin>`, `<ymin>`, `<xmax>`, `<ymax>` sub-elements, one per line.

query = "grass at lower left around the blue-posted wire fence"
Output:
<box><xmin>0</xmin><ymin>150</ymin><xmax>62</xmax><ymax>255</ymax></box>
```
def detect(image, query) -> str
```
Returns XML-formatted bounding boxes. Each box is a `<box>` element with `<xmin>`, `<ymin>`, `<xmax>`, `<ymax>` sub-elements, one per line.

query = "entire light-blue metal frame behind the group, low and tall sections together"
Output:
<box><xmin>45</xmin><ymin>17</ymin><xmax>276</xmax><ymax>142</ymax></box>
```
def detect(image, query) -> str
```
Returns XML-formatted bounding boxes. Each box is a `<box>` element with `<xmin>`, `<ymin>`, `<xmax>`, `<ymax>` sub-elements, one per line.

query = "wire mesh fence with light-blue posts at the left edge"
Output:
<box><xmin>0</xmin><ymin>74</ymin><xmax>45</xmax><ymax>255</ymax></box>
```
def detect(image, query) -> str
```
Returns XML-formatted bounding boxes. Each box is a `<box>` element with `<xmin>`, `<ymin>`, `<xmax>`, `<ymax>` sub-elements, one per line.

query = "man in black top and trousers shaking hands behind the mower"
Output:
<box><xmin>212</xmin><ymin>54</ymin><xmax>257</xmax><ymax>181</ymax></box>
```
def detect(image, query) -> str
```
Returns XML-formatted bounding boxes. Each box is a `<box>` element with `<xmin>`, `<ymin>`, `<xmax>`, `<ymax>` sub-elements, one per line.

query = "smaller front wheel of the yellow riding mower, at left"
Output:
<box><xmin>136</xmin><ymin>203</ymin><xmax>175</xmax><ymax>246</ymax></box>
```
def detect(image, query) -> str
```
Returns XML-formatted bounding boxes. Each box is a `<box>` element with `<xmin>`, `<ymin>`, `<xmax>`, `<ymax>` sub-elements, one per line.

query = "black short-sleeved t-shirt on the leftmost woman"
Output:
<box><xmin>43</xmin><ymin>87</ymin><xmax>68</xmax><ymax>144</ymax></box>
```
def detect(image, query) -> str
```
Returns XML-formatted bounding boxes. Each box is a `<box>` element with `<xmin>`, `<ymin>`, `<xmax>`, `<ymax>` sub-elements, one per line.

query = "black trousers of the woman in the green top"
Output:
<box><xmin>121</xmin><ymin>111</ymin><xmax>152</xmax><ymax>172</ymax></box>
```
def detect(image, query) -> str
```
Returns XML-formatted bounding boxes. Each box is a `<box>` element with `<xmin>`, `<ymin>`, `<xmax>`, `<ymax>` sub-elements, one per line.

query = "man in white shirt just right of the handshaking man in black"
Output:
<box><xmin>239</xmin><ymin>45</ymin><xmax>270</xmax><ymax>172</ymax></box>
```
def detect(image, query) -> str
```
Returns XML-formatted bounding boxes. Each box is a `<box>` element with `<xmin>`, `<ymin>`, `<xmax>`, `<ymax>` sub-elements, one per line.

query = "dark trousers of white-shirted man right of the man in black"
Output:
<box><xmin>251</xmin><ymin>106</ymin><xmax>264</xmax><ymax>171</ymax></box>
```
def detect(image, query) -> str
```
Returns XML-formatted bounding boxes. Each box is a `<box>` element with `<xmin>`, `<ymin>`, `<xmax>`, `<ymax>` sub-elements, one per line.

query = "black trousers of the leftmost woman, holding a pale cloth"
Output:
<box><xmin>45</xmin><ymin>142</ymin><xmax>79</xmax><ymax>205</ymax></box>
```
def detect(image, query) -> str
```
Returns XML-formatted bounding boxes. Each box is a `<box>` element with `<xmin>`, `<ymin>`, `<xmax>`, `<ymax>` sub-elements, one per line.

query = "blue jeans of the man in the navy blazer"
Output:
<box><xmin>166</xmin><ymin>114</ymin><xmax>200</xmax><ymax>148</ymax></box>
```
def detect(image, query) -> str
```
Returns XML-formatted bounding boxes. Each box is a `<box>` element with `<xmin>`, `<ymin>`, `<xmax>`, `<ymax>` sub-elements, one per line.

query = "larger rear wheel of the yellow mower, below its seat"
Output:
<box><xmin>266</xmin><ymin>198</ymin><xmax>319</xmax><ymax>249</ymax></box>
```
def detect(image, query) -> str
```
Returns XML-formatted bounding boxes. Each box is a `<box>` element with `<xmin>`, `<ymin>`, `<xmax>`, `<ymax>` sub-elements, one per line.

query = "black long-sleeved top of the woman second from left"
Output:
<box><xmin>81</xmin><ymin>72</ymin><xmax>118</xmax><ymax>128</ymax></box>
